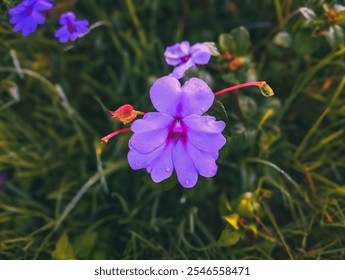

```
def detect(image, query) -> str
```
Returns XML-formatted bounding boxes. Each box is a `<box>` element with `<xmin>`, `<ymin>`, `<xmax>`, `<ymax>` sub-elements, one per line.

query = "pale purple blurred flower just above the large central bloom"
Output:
<box><xmin>164</xmin><ymin>41</ymin><xmax>211</xmax><ymax>79</ymax></box>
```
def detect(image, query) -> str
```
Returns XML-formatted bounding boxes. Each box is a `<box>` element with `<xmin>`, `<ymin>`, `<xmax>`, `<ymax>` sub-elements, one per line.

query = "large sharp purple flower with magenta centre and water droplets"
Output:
<box><xmin>127</xmin><ymin>77</ymin><xmax>225</xmax><ymax>188</ymax></box>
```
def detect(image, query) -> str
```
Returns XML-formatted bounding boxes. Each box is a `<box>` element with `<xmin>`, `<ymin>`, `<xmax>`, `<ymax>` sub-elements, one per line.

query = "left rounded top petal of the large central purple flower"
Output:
<box><xmin>150</xmin><ymin>77</ymin><xmax>181</xmax><ymax>116</ymax></box>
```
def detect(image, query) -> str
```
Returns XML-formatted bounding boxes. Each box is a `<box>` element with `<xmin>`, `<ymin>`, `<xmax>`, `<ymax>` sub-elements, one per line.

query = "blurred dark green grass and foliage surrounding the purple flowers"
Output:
<box><xmin>0</xmin><ymin>0</ymin><xmax>345</xmax><ymax>259</ymax></box>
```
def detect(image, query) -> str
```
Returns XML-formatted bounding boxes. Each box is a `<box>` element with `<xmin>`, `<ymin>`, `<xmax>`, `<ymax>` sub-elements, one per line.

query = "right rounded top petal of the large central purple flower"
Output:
<box><xmin>182</xmin><ymin>78</ymin><xmax>214</xmax><ymax>116</ymax></box>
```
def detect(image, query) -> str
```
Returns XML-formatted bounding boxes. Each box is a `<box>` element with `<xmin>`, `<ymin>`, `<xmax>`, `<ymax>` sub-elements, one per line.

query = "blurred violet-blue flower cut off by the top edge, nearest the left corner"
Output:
<box><xmin>8</xmin><ymin>0</ymin><xmax>53</xmax><ymax>36</ymax></box>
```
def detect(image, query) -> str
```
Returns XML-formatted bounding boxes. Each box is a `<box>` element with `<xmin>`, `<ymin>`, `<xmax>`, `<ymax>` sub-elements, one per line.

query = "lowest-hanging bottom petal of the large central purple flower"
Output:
<box><xmin>172</xmin><ymin>141</ymin><xmax>198</xmax><ymax>188</ymax></box>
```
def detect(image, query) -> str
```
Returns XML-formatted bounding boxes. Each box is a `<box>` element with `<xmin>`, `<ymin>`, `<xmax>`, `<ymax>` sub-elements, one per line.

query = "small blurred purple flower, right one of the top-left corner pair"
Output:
<box><xmin>54</xmin><ymin>12</ymin><xmax>89</xmax><ymax>43</ymax></box>
